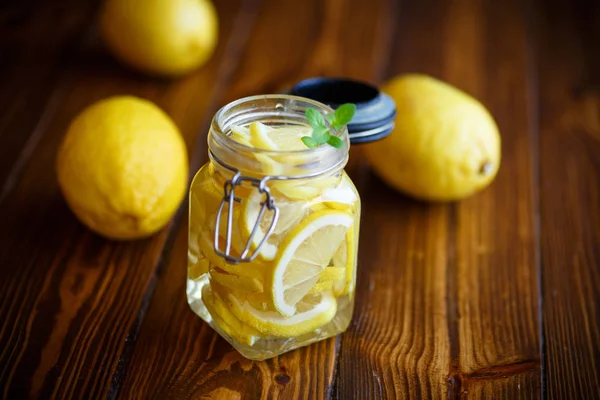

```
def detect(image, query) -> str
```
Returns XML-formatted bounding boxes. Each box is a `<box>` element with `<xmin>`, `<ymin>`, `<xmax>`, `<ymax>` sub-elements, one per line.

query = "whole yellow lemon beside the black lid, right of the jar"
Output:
<box><xmin>365</xmin><ymin>74</ymin><xmax>500</xmax><ymax>201</ymax></box>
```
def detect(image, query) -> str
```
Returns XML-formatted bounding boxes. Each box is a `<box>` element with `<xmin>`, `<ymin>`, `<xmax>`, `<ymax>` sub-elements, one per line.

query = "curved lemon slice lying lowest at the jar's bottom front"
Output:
<box><xmin>228</xmin><ymin>292</ymin><xmax>337</xmax><ymax>337</ymax></box>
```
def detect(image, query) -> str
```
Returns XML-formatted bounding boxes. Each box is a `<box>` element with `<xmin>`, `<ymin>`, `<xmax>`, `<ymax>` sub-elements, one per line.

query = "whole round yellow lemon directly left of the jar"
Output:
<box><xmin>56</xmin><ymin>96</ymin><xmax>188</xmax><ymax>239</ymax></box>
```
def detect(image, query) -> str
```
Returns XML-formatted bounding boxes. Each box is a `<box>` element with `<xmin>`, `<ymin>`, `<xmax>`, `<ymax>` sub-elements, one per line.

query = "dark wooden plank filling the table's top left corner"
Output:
<box><xmin>0</xmin><ymin>1</ymin><xmax>98</xmax><ymax>201</ymax></box>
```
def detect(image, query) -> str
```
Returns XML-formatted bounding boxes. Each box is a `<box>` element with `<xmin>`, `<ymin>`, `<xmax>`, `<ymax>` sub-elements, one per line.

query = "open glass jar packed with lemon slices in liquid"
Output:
<box><xmin>187</xmin><ymin>95</ymin><xmax>360</xmax><ymax>360</ymax></box>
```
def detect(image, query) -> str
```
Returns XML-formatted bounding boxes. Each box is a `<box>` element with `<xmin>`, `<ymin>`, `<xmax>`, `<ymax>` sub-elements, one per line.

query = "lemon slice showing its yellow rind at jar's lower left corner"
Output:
<box><xmin>202</xmin><ymin>285</ymin><xmax>261</xmax><ymax>346</ymax></box>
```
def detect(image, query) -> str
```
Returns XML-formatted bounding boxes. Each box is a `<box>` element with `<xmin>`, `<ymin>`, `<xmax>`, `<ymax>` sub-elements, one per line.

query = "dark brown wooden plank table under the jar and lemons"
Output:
<box><xmin>0</xmin><ymin>0</ymin><xmax>600</xmax><ymax>400</ymax></box>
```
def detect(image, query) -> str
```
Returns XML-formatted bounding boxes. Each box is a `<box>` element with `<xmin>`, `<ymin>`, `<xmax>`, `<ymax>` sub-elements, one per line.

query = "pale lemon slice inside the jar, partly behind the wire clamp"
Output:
<box><xmin>239</xmin><ymin>189</ymin><xmax>307</xmax><ymax>261</ymax></box>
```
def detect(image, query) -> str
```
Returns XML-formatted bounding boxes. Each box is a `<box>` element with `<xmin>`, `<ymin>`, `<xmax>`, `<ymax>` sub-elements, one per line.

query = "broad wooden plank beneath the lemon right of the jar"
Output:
<box><xmin>338</xmin><ymin>0</ymin><xmax>540</xmax><ymax>398</ymax></box>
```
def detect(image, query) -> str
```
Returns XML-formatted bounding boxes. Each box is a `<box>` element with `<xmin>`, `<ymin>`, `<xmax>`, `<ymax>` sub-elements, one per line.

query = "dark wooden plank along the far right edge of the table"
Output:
<box><xmin>536</xmin><ymin>1</ymin><xmax>600</xmax><ymax>399</ymax></box>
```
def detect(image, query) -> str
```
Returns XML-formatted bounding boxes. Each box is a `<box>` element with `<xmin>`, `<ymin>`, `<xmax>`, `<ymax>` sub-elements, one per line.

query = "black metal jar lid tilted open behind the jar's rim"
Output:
<box><xmin>290</xmin><ymin>77</ymin><xmax>396</xmax><ymax>144</ymax></box>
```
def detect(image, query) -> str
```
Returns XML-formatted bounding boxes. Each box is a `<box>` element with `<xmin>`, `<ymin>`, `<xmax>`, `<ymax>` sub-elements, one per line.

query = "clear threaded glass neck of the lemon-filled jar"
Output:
<box><xmin>208</xmin><ymin>95</ymin><xmax>349</xmax><ymax>179</ymax></box>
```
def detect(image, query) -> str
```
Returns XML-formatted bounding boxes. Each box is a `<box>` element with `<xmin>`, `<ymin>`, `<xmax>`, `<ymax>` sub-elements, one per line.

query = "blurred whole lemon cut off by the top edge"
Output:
<box><xmin>100</xmin><ymin>0</ymin><xmax>218</xmax><ymax>76</ymax></box>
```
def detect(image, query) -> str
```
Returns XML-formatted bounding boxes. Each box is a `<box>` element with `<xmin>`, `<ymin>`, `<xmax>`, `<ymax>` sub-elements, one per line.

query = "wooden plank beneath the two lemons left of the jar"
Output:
<box><xmin>0</xmin><ymin>1</ymin><xmax>244</xmax><ymax>399</ymax></box>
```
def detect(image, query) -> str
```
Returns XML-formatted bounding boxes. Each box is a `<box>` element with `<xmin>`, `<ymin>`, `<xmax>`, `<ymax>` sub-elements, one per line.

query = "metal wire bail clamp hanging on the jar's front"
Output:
<box><xmin>214</xmin><ymin>171</ymin><xmax>279</xmax><ymax>264</ymax></box>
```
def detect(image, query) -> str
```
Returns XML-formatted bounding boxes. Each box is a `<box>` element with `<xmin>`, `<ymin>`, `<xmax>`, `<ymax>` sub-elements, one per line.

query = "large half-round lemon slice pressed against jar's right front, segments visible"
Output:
<box><xmin>272</xmin><ymin>210</ymin><xmax>354</xmax><ymax>316</ymax></box>
